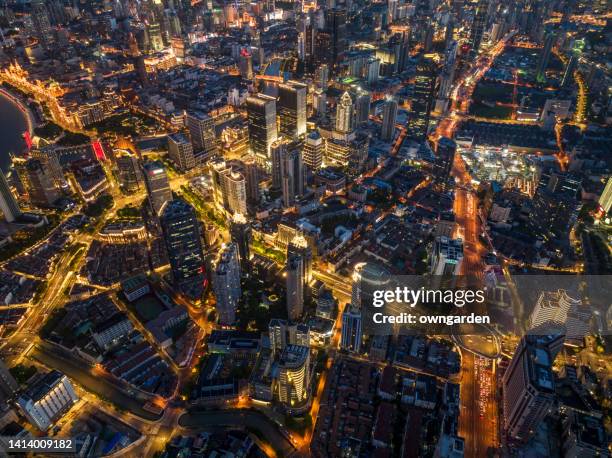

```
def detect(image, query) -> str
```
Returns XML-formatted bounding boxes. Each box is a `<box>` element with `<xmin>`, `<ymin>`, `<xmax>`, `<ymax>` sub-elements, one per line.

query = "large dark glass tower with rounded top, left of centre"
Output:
<box><xmin>160</xmin><ymin>199</ymin><xmax>205</xmax><ymax>299</ymax></box>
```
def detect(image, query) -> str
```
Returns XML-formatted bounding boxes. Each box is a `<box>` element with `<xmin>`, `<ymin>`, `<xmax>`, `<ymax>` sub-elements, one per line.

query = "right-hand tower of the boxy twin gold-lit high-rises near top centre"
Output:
<box><xmin>278</xmin><ymin>81</ymin><xmax>308</xmax><ymax>138</ymax></box>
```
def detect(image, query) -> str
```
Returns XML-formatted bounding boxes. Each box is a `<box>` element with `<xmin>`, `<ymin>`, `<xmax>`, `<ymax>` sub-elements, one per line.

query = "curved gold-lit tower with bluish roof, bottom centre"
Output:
<box><xmin>278</xmin><ymin>345</ymin><xmax>310</xmax><ymax>408</ymax></box>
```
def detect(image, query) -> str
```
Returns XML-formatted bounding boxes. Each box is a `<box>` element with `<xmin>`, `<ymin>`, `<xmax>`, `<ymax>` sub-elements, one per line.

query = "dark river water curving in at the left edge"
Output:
<box><xmin>0</xmin><ymin>93</ymin><xmax>28</xmax><ymax>172</ymax></box>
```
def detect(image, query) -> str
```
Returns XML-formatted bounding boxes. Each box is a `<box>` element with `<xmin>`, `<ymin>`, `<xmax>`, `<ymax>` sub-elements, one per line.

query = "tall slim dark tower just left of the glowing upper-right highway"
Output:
<box><xmin>408</xmin><ymin>58</ymin><xmax>437</xmax><ymax>142</ymax></box>
